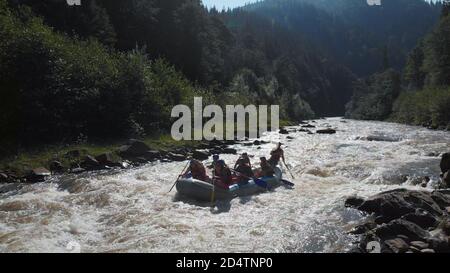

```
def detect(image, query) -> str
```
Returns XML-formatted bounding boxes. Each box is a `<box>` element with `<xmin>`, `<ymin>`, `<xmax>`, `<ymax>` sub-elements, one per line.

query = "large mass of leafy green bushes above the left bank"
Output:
<box><xmin>0</xmin><ymin>0</ymin><xmax>196</xmax><ymax>154</ymax></box>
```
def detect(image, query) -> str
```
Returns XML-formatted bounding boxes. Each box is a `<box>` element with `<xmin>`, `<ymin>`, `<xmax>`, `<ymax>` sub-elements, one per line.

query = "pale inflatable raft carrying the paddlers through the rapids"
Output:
<box><xmin>176</xmin><ymin>168</ymin><xmax>283</xmax><ymax>202</ymax></box>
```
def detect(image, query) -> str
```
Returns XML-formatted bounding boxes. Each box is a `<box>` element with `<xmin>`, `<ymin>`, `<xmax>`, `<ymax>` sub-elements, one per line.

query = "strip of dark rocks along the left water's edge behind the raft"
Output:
<box><xmin>0</xmin><ymin>139</ymin><xmax>239</xmax><ymax>184</ymax></box>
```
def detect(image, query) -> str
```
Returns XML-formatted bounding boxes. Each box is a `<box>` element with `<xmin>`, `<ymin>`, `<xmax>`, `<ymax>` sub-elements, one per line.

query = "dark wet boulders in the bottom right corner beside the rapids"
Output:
<box><xmin>345</xmin><ymin>153</ymin><xmax>450</xmax><ymax>253</ymax></box>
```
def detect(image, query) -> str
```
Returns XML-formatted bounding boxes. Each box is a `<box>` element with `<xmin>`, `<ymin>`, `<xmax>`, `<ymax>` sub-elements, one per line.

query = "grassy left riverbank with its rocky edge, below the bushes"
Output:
<box><xmin>0</xmin><ymin>120</ymin><xmax>294</xmax><ymax>183</ymax></box>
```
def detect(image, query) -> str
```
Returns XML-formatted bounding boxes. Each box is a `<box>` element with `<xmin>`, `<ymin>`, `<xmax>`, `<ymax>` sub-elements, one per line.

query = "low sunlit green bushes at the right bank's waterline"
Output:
<box><xmin>392</xmin><ymin>87</ymin><xmax>450</xmax><ymax>128</ymax></box>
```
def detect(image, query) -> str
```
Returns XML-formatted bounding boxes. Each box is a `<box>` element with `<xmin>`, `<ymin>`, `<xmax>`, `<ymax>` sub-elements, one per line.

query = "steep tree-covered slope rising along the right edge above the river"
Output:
<box><xmin>347</xmin><ymin>3</ymin><xmax>450</xmax><ymax>129</ymax></box>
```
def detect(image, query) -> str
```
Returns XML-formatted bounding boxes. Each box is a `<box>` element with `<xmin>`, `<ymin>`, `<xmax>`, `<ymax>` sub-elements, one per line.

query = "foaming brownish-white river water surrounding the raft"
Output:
<box><xmin>0</xmin><ymin>118</ymin><xmax>450</xmax><ymax>253</ymax></box>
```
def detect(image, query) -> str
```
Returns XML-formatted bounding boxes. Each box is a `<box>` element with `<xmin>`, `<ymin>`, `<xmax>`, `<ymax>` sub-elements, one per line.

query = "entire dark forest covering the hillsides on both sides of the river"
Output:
<box><xmin>0</xmin><ymin>0</ymin><xmax>450</xmax><ymax>154</ymax></box>
